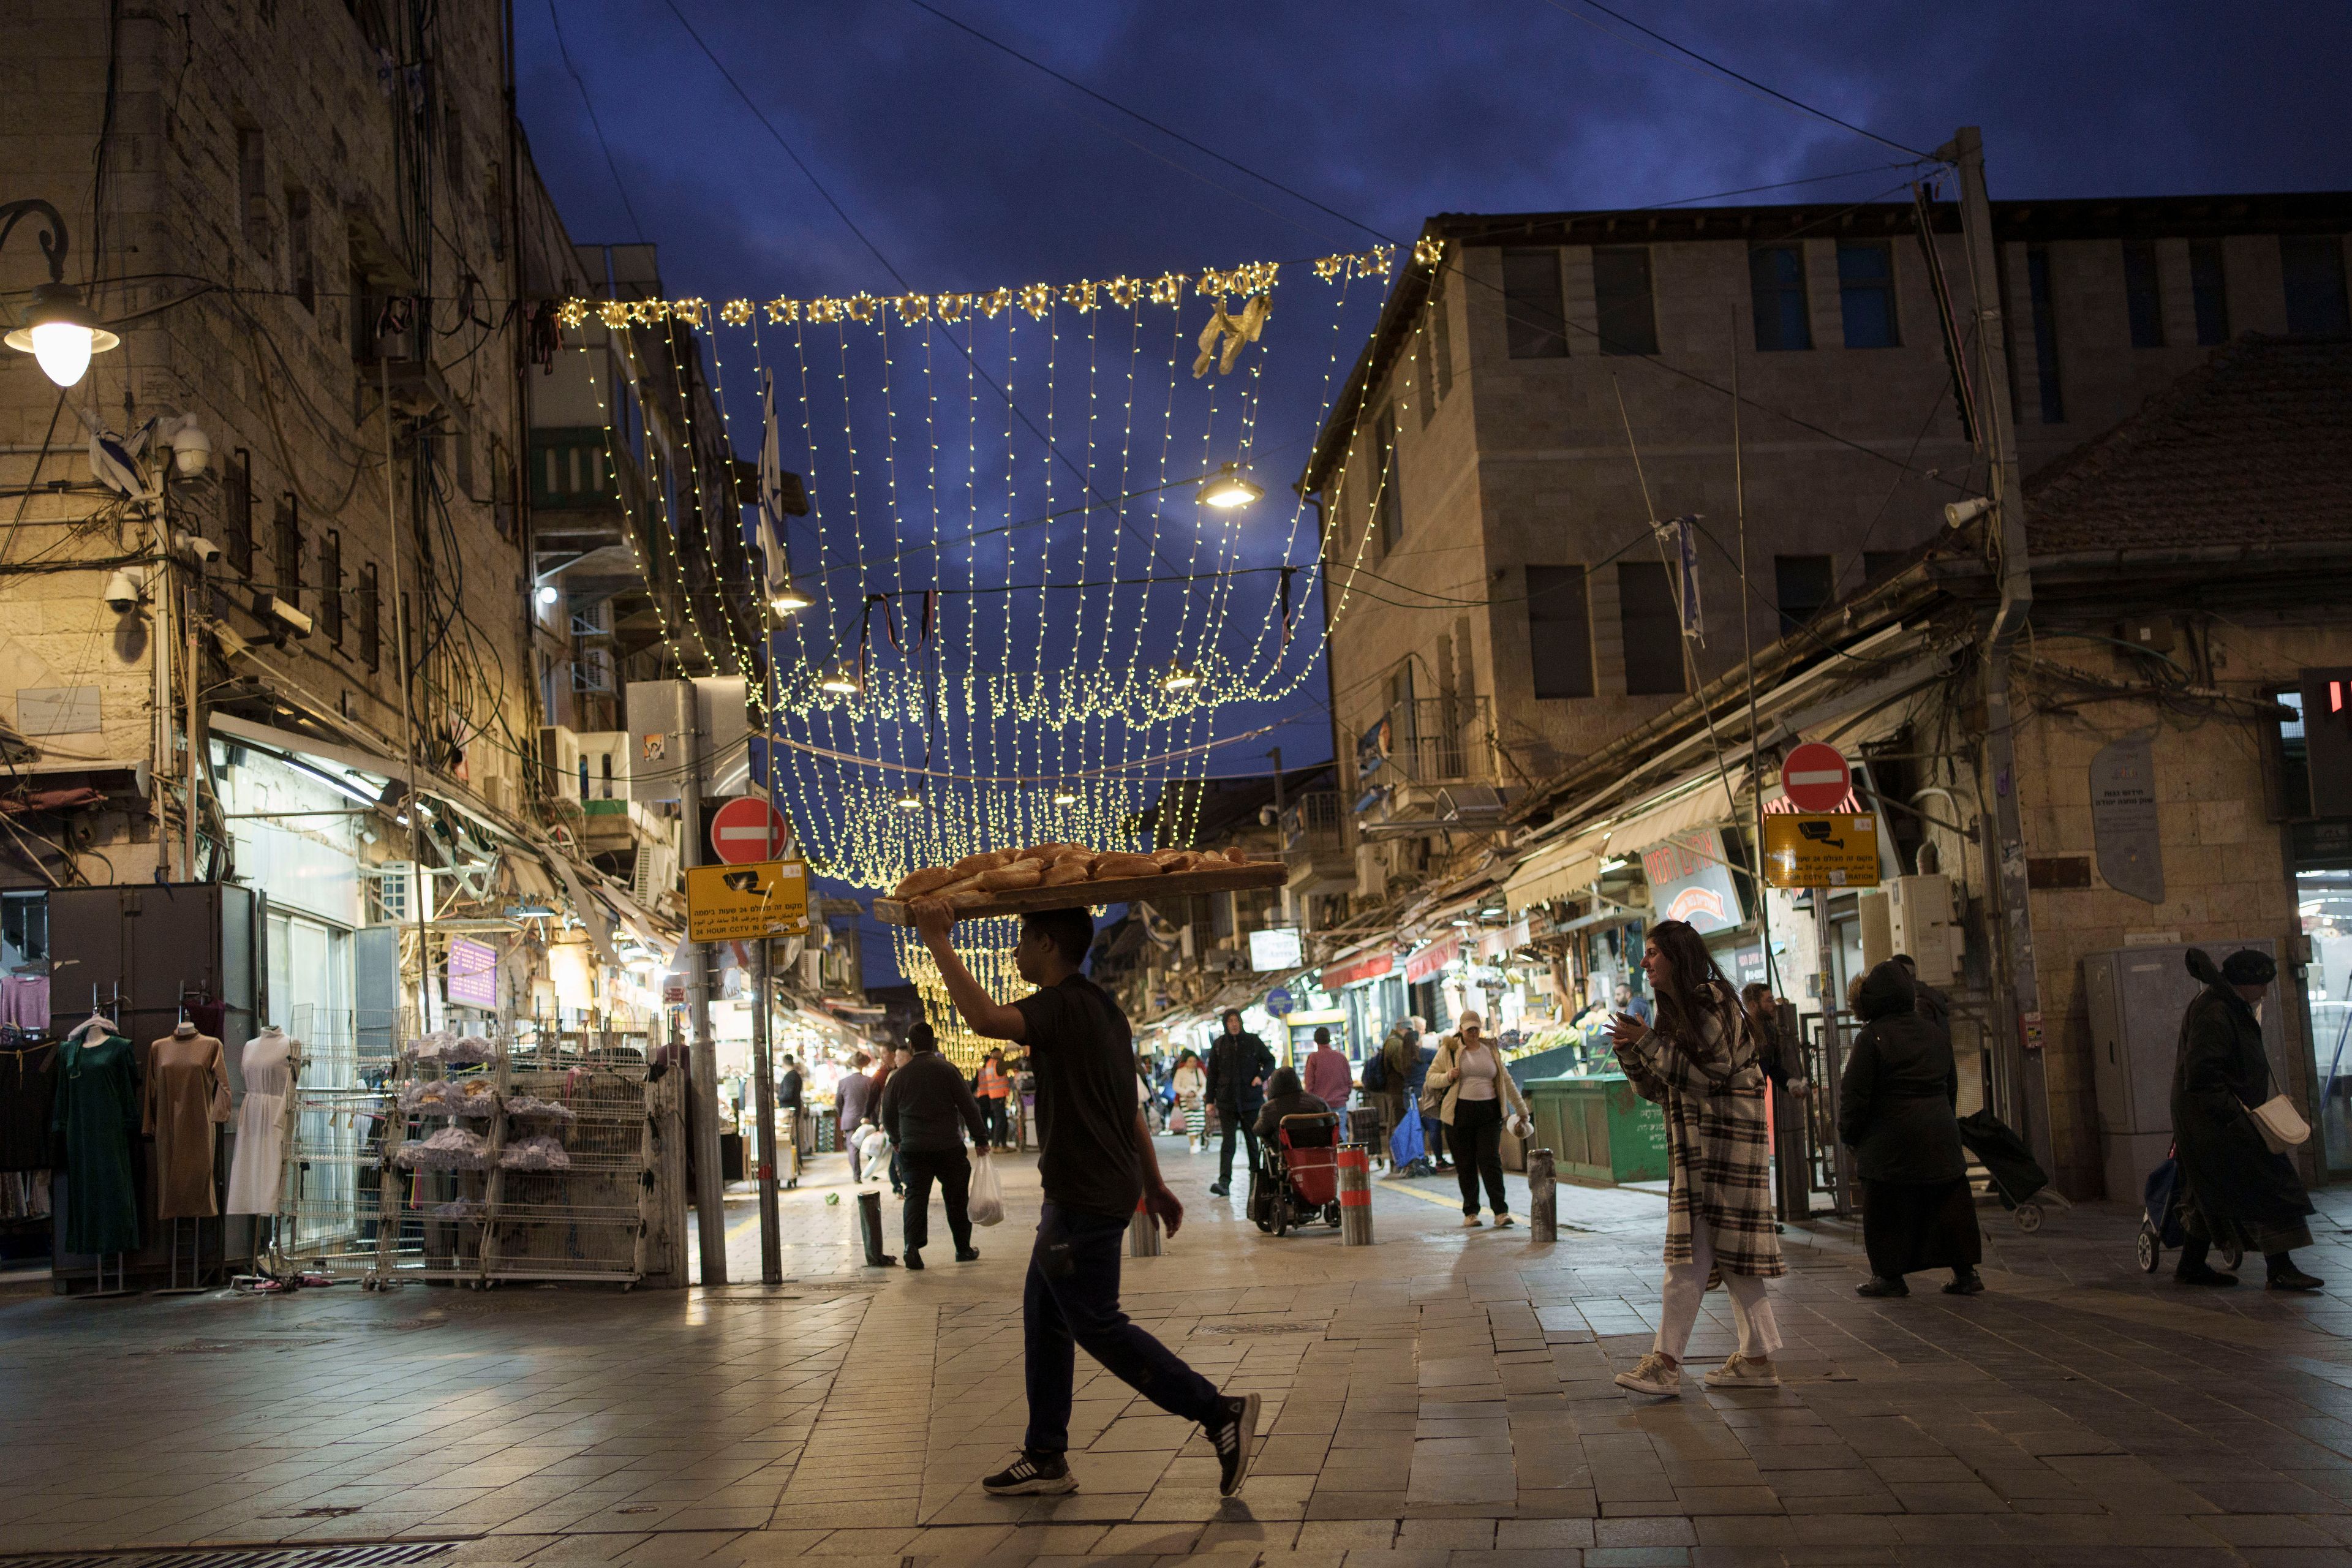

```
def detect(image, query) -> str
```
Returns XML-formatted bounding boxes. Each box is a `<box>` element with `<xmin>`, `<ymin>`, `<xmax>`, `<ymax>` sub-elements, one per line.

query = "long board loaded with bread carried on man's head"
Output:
<box><xmin>873</xmin><ymin>844</ymin><xmax>1289</xmax><ymax>926</ymax></box>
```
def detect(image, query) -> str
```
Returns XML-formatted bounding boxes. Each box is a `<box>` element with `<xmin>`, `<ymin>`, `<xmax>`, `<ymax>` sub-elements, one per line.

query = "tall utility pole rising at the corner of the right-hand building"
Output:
<box><xmin>1938</xmin><ymin>124</ymin><xmax>2056</xmax><ymax>1170</ymax></box>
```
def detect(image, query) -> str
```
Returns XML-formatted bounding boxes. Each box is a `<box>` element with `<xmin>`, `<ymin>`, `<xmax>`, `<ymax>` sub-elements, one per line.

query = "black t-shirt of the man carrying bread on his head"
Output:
<box><xmin>1014</xmin><ymin>976</ymin><xmax>1143</xmax><ymax>1220</ymax></box>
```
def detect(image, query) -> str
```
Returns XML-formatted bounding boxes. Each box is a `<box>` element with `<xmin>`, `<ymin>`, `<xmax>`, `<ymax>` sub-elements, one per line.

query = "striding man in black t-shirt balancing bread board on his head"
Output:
<box><xmin>910</xmin><ymin>898</ymin><xmax>1258</xmax><ymax>1498</ymax></box>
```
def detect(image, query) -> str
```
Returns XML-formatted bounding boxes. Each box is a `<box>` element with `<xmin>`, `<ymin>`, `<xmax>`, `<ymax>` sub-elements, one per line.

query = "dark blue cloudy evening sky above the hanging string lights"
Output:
<box><xmin>518</xmin><ymin>0</ymin><xmax>2352</xmax><ymax>980</ymax></box>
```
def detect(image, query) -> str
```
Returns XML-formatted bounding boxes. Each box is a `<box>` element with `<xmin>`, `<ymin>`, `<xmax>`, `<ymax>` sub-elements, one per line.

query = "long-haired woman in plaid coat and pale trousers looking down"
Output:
<box><xmin>1609</xmin><ymin>919</ymin><xmax>1787</xmax><ymax>1394</ymax></box>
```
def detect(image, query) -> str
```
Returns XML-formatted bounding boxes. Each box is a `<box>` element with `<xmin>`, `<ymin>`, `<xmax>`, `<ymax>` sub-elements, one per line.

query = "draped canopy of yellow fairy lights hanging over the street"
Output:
<box><xmin>576</xmin><ymin>244</ymin><xmax>1442</xmax><ymax>888</ymax></box>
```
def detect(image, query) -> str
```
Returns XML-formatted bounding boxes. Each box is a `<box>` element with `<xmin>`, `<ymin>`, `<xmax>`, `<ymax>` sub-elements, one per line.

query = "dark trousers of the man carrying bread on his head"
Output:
<box><xmin>1021</xmin><ymin>1201</ymin><xmax>1218</xmax><ymax>1453</ymax></box>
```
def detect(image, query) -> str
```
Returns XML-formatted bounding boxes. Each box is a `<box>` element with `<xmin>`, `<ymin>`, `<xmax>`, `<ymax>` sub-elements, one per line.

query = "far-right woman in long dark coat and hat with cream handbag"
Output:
<box><xmin>2173</xmin><ymin>948</ymin><xmax>2321</xmax><ymax>1291</ymax></box>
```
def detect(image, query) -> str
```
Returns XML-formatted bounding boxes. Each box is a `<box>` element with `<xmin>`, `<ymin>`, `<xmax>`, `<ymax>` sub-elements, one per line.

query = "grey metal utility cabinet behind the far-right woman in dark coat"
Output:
<box><xmin>2081</xmin><ymin>938</ymin><xmax>2293</xmax><ymax>1204</ymax></box>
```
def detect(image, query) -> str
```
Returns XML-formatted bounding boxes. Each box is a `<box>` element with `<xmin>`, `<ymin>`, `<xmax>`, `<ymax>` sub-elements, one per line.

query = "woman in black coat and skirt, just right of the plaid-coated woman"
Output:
<box><xmin>1837</xmin><ymin>962</ymin><xmax>1985</xmax><ymax>1295</ymax></box>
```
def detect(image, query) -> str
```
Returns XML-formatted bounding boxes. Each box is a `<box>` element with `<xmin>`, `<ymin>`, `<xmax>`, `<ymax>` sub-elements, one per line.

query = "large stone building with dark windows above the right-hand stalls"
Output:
<box><xmin>1303</xmin><ymin>195</ymin><xmax>2352</xmax><ymax>921</ymax></box>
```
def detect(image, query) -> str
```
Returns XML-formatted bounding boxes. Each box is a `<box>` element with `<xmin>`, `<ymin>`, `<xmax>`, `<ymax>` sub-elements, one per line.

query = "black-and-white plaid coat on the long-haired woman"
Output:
<box><xmin>1616</xmin><ymin>1001</ymin><xmax>1787</xmax><ymax>1276</ymax></box>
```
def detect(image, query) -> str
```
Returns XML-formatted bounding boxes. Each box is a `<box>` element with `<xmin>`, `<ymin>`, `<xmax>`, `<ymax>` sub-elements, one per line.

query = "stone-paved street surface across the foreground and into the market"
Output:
<box><xmin>0</xmin><ymin>1140</ymin><xmax>2352</xmax><ymax>1568</ymax></box>
